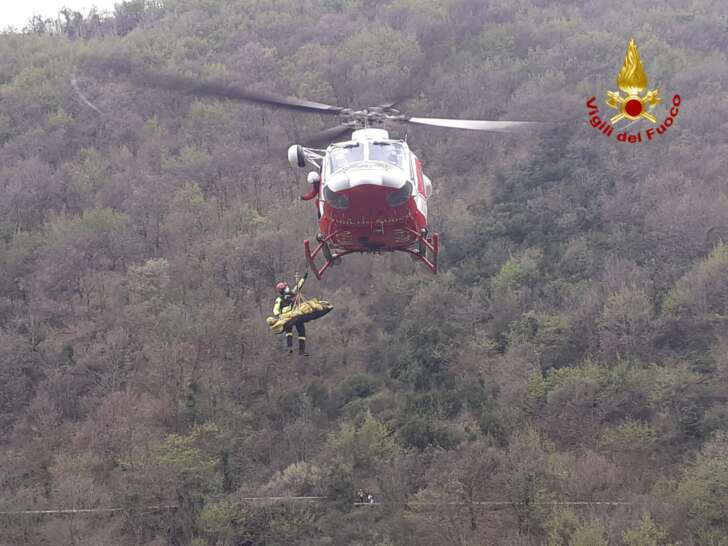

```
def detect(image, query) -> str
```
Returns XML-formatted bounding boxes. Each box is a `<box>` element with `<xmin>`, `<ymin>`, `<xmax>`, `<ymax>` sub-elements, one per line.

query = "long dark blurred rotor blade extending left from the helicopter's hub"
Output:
<box><xmin>132</xmin><ymin>72</ymin><xmax>343</xmax><ymax>115</ymax></box>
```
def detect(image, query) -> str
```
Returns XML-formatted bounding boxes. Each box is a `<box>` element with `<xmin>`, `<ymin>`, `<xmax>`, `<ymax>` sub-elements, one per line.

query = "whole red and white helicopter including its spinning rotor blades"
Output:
<box><xmin>72</xmin><ymin>63</ymin><xmax>544</xmax><ymax>280</ymax></box>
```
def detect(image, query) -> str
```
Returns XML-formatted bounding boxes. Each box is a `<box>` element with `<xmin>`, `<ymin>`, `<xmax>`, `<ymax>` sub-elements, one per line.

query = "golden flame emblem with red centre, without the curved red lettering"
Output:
<box><xmin>606</xmin><ymin>38</ymin><xmax>662</xmax><ymax>124</ymax></box>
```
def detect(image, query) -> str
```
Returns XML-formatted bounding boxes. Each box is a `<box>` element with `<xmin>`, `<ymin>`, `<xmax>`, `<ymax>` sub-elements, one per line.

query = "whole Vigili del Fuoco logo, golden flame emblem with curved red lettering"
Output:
<box><xmin>586</xmin><ymin>39</ymin><xmax>680</xmax><ymax>144</ymax></box>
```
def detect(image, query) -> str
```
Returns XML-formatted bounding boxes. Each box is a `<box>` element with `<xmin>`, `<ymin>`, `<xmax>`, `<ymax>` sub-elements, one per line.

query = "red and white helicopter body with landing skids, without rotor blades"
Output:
<box><xmin>294</xmin><ymin>129</ymin><xmax>438</xmax><ymax>277</ymax></box>
